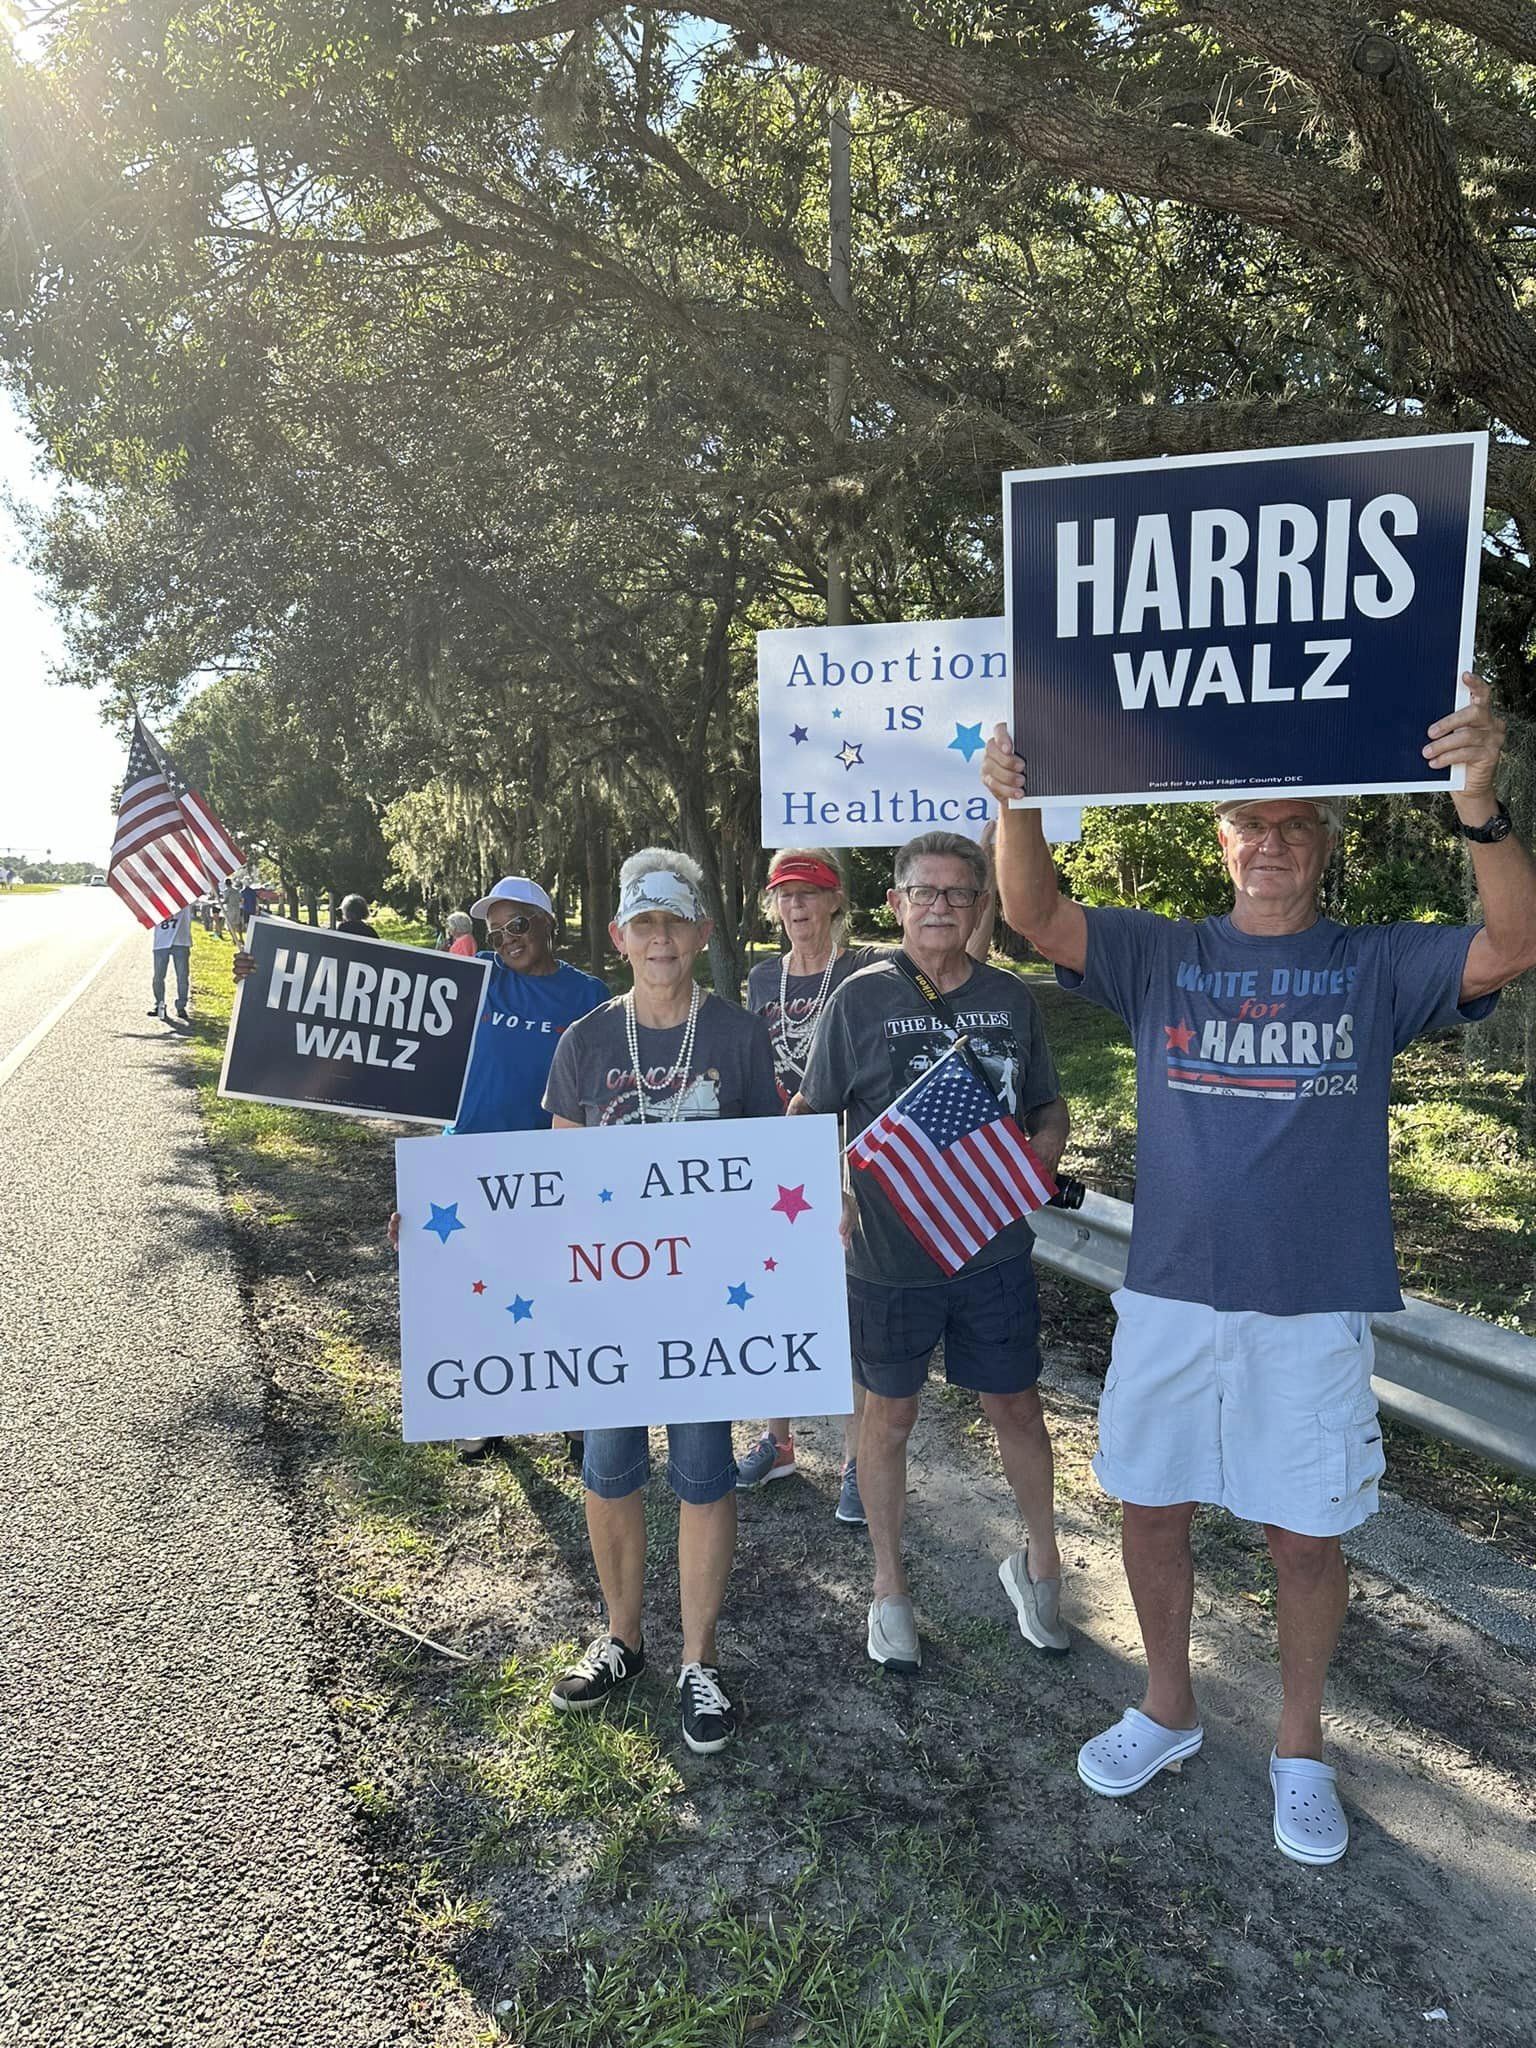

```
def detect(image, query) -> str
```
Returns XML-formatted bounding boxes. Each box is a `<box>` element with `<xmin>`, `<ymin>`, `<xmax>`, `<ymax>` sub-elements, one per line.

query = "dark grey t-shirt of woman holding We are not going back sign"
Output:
<box><xmin>545</xmin><ymin>995</ymin><xmax>782</xmax><ymax>1124</ymax></box>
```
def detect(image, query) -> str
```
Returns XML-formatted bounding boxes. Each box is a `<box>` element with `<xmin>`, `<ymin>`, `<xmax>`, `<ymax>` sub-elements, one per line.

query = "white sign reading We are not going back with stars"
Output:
<box><xmin>395</xmin><ymin>1116</ymin><xmax>854</xmax><ymax>1444</ymax></box>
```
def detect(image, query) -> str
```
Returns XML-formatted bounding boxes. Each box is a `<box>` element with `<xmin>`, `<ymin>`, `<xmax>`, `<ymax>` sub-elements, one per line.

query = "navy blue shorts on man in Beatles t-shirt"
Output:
<box><xmin>848</xmin><ymin>1257</ymin><xmax>1040</xmax><ymax>1401</ymax></box>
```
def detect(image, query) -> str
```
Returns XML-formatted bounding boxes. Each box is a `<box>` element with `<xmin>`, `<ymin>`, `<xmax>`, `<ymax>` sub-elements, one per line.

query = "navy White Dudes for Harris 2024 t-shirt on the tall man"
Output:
<box><xmin>1057</xmin><ymin>909</ymin><xmax>1497</xmax><ymax>1315</ymax></box>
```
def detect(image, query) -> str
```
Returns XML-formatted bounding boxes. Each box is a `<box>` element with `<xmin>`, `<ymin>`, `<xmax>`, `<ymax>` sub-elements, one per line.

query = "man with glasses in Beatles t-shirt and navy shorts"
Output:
<box><xmin>788</xmin><ymin>831</ymin><xmax>1071</xmax><ymax>1673</ymax></box>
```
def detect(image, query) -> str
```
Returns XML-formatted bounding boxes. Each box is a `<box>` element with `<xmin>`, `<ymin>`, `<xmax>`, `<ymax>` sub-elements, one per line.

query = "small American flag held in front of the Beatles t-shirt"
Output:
<box><xmin>848</xmin><ymin>1040</ymin><xmax>1057</xmax><ymax>1274</ymax></box>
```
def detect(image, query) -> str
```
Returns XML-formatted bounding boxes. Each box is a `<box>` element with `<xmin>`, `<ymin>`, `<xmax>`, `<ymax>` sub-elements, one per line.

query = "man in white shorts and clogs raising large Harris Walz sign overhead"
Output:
<box><xmin>983</xmin><ymin>676</ymin><xmax>1536</xmax><ymax>1864</ymax></box>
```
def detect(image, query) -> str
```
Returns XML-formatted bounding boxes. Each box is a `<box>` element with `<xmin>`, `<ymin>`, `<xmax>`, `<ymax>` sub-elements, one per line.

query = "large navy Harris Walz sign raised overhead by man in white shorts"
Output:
<box><xmin>1004</xmin><ymin>434</ymin><xmax>1487</xmax><ymax>807</ymax></box>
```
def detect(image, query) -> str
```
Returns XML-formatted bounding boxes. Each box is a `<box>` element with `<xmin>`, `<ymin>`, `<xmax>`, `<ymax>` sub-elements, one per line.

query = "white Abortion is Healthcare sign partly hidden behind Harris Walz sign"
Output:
<box><xmin>758</xmin><ymin>618</ymin><xmax>1081</xmax><ymax>846</ymax></box>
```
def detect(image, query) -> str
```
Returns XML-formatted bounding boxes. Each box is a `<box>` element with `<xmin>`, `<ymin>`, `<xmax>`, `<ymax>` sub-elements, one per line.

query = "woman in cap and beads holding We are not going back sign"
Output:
<box><xmin>545</xmin><ymin>846</ymin><xmax>780</xmax><ymax>1755</ymax></box>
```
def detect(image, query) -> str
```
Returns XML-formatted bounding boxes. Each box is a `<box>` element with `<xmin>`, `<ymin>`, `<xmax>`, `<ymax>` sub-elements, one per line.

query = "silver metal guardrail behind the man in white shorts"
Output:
<box><xmin>1030</xmin><ymin>1192</ymin><xmax>1536</xmax><ymax>1477</ymax></box>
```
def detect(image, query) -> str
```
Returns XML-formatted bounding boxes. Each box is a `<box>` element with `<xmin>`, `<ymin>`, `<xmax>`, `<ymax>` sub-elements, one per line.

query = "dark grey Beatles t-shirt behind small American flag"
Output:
<box><xmin>801</xmin><ymin>956</ymin><xmax>1061</xmax><ymax>1286</ymax></box>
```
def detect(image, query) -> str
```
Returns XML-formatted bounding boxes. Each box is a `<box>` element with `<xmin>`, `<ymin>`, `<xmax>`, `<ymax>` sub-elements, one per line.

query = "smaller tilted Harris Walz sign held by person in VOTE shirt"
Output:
<box><xmin>219</xmin><ymin>918</ymin><xmax>487</xmax><ymax>1124</ymax></box>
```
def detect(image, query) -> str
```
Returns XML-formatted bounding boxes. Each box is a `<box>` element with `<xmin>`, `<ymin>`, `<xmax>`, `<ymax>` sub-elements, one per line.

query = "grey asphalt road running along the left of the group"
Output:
<box><xmin>0</xmin><ymin>891</ymin><xmax>410</xmax><ymax>2048</ymax></box>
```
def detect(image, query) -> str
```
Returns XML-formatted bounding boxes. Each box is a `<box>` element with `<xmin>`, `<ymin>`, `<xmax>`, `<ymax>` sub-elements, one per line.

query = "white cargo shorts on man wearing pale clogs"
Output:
<box><xmin>1094</xmin><ymin>1288</ymin><xmax>1386</xmax><ymax>1536</ymax></box>
